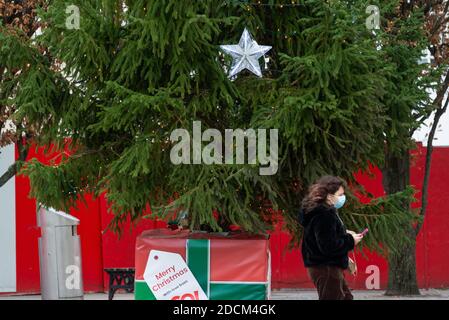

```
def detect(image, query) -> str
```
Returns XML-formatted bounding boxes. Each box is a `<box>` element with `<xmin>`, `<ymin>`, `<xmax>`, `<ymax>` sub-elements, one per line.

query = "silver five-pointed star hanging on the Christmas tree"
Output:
<box><xmin>220</xmin><ymin>28</ymin><xmax>271</xmax><ymax>78</ymax></box>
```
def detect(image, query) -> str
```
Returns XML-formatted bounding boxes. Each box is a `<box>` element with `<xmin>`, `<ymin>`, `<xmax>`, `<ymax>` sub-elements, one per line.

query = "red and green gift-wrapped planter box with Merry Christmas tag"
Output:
<box><xmin>134</xmin><ymin>229</ymin><xmax>271</xmax><ymax>300</ymax></box>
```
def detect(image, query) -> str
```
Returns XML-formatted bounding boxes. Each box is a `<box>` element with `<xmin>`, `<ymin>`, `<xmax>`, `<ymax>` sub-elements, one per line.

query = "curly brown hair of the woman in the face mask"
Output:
<box><xmin>302</xmin><ymin>176</ymin><xmax>346</xmax><ymax>213</ymax></box>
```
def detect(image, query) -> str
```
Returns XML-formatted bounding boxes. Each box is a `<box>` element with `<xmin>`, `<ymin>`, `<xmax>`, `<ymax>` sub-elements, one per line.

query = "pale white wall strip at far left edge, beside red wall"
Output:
<box><xmin>0</xmin><ymin>144</ymin><xmax>16</xmax><ymax>292</ymax></box>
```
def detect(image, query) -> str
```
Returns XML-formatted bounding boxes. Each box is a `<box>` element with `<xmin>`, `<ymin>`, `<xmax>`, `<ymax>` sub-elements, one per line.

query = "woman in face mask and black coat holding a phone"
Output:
<box><xmin>298</xmin><ymin>176</ymin><xmax>363</xmax><ymax>300</ymax></box>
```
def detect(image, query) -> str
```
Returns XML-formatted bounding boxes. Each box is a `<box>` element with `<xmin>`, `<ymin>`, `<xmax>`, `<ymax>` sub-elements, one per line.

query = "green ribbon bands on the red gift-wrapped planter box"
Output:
<box><xmin>134</xmin><ymin>239</ymin><xmax>268</xmax><ymax>300</ymax></box>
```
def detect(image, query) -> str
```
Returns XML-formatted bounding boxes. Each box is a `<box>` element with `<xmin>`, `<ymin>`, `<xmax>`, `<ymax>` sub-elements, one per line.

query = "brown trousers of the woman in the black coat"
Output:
<box><xmin>307</xmin><ymin>266</ymin><xmax>354</xmax><ymax>300</ymax></box>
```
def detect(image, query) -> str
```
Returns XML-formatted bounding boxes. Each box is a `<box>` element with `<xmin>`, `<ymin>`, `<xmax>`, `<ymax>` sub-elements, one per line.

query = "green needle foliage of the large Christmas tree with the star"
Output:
<box><xmin>0</xmin><ymin>0</ymin><xmax>428</xmax><ymax>252</ymax></box>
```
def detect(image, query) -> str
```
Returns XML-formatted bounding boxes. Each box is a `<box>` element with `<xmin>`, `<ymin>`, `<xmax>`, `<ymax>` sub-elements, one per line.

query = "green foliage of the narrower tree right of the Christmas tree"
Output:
<box><xmin>372</xmin><ymin>1</ymin><xmax>439</xmax><ymax>154</ymax></box>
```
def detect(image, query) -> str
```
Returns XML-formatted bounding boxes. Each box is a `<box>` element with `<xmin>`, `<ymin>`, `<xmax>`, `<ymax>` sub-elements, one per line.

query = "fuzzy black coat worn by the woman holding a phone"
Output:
<box><xmin>298</xmin><ymin>204</ymin><xmax>354</xmax><ymax>269</ymax></box>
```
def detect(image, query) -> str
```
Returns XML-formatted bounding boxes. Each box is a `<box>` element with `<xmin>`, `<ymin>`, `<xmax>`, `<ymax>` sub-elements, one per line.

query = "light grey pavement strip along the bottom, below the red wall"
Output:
<box><xmin>0</xmin><ymin>289</ymin><xmax>449</xmax><ymax>300</ymax></box>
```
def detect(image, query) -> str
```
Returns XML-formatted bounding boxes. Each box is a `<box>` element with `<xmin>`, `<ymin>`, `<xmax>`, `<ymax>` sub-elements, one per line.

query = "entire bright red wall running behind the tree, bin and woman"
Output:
<box><xmin>2</xmin><ymin>144</ymin><xmax>449</xmax><ymax>293</ymax></box>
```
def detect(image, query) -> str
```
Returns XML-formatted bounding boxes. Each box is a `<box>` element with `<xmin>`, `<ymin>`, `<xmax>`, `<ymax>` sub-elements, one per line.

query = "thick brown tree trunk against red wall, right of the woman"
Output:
<box><xmin>383</xmin><ymin>151</ymin><xmax>420</xmax><ymax>295</ymax></box>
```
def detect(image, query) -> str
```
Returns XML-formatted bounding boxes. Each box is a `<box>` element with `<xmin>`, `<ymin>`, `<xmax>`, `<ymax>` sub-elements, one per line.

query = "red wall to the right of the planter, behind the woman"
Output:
<box><xmin>271</xmin><ymin>147</ymin><xmax>449</xmax><ymax>289</ymax></box>
